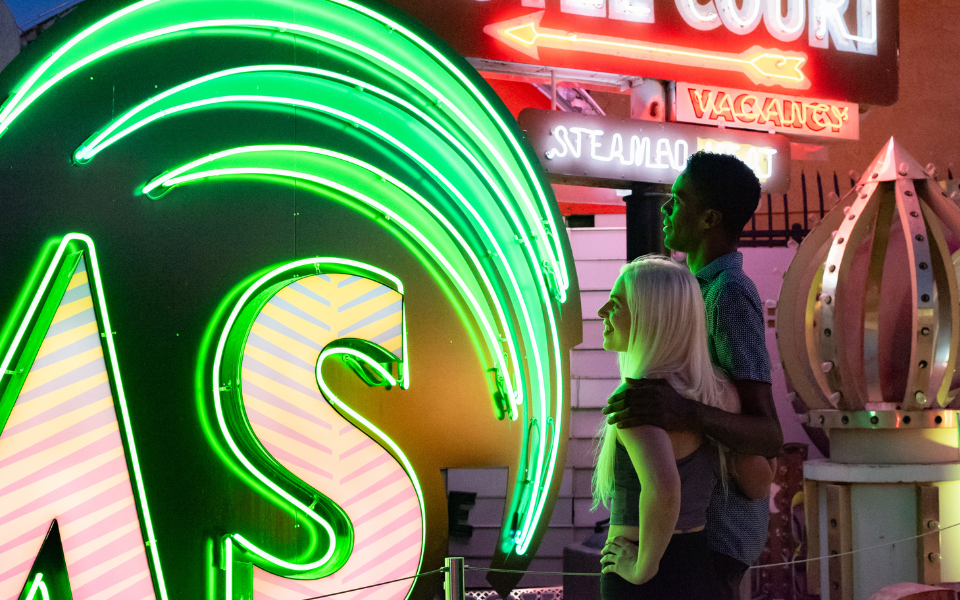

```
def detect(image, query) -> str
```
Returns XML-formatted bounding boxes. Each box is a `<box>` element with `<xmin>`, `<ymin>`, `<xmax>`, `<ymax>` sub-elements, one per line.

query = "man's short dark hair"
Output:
<box><xmin>684</xmin><ymin>150</ymin><xmax>760</xmax><ymax>238</ymax></box>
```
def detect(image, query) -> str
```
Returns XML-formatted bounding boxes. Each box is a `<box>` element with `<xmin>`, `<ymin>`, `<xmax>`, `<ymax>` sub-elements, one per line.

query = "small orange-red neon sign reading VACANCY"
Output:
<box><xmin>676</xmin><ymin>82</ymin><xmax>860</xmax><ymax>140</ymax></box>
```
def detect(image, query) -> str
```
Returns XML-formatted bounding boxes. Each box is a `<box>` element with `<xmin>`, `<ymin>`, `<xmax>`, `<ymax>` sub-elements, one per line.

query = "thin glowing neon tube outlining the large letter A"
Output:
<box><xmin>0</xmin><ymin>233</ymin><xmax>168</xmax><ymax>600</ymax></box>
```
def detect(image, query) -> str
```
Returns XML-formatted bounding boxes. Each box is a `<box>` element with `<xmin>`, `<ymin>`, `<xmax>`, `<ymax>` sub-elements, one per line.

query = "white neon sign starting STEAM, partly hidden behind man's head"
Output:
<box><xmin>519</xmin><ymin>108</ymin><xmax>790</xmax><ymax>192</ymax></box>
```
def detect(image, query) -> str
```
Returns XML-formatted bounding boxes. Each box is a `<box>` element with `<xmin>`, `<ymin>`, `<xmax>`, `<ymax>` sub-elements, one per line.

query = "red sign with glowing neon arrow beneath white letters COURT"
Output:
<box><xmin>378</xmin><ymin>0</ymin><xmax>899</xmax><ymax>105</ymax></box>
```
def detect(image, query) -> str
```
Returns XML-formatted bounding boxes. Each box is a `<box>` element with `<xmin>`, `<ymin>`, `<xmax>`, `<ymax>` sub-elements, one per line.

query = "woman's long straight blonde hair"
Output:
<box><xmin>593</xmin><ymin>254</ymin><xmax>740</xmax><ymax>508</ymax></box>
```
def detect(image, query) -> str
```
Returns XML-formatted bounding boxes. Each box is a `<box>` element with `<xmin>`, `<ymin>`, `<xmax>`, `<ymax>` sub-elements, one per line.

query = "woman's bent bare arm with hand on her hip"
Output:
<box><xmin>601</xmin><ymin>425</ymin><xmax>680</xmax><ymax>584</ymax></box>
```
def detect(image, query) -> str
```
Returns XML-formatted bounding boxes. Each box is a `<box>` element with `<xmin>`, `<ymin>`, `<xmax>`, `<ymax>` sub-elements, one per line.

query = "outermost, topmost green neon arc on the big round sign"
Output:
<box><xmin>0</xmin><ymin>8</ymin><xmax>569</xmax><ymax>303</ymax></box>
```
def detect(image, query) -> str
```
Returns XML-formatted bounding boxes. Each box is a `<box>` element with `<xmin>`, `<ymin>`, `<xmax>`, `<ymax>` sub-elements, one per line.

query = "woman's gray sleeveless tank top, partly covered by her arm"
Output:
<box><xmin>610</xmin><ymin>442</ymin><xmax>720</xmax><ymax>530</ymax></box>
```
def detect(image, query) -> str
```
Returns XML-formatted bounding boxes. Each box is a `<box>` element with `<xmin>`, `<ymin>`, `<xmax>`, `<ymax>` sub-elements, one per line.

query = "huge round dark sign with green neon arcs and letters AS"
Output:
<box><xmin>0</xmin><ymin>0</ymin><xmax>580</xmax><ymax>600</ymax></box>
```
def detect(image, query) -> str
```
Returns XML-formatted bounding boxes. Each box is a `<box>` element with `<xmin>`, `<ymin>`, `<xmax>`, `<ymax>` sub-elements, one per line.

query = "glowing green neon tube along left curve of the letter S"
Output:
<box><xmin>209</xmin><ymin>257</ymin><xmax>412</xmax><ymax>576</ymax></box>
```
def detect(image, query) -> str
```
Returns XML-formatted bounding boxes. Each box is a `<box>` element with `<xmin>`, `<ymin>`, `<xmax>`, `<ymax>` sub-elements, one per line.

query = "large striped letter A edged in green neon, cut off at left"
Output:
<box><xmin>0</xmin><ymin>234</ymin><xmax>166</xmax><ymax>600</ymax></box>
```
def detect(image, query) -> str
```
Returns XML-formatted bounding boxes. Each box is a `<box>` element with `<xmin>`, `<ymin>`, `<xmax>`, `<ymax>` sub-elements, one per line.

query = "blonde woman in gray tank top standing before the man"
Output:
<box><xmin>593</xmin><ymin>255</ymin><xmax>773</xmax><ymax>600</ymax></box>
